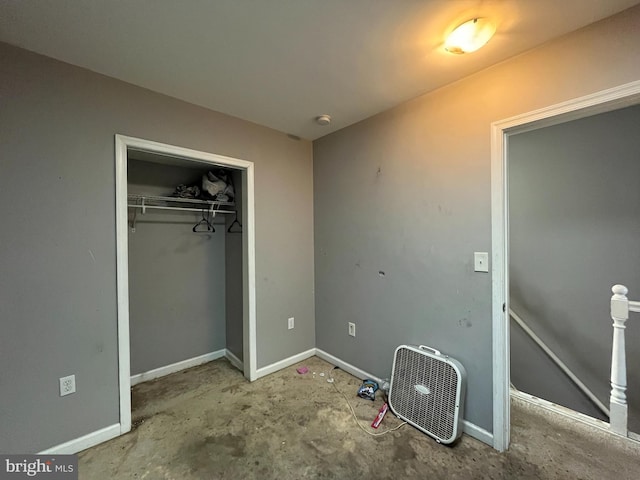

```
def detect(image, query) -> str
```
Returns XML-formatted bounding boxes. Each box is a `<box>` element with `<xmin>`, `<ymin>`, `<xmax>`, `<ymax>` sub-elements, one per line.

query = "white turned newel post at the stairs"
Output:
<box><xmin>609</xmin><ymin>285</ymin><xmax>629</xmax><ymax>437</ymax></box>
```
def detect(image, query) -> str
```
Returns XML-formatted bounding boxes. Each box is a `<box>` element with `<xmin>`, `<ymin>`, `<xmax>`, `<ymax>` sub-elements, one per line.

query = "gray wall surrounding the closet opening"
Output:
<box><xmin>0</xmin><ymin>44</ymin><xmax>315</xmax><ymax>453</ymax></box>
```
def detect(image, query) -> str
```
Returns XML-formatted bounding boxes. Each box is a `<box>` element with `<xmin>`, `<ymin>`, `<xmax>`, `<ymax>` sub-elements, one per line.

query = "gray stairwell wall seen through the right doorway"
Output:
<box><xmin>509</xmin><ymin>106</ymin><xmax>640</xmax><ymax>432</ymax></box>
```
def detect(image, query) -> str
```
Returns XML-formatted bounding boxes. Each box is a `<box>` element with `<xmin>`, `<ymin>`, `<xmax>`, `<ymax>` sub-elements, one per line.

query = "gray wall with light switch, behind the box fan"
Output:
<box><xmin>314</xmin><ymin>8</ymin><xmax>640</xmax><ymax>431</ymax></box>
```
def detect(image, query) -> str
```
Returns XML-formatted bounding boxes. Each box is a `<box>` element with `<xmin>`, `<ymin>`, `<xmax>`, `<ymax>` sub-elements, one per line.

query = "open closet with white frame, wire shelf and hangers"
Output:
<box><xmin>116</xmin><ymin>135</ymin><xmax>256</xmax><ymax>434</ymax></box>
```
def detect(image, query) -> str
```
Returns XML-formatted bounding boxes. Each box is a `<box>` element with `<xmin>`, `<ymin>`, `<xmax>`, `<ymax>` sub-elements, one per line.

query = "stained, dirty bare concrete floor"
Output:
<box><xmin>79</xmin><ymin>357</ymin><xmax>640</xmax><ymax>480</ymax></box>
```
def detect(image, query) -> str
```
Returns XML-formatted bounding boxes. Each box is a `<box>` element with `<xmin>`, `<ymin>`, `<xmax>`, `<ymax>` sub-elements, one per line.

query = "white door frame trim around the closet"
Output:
<box><xmin>115</xmin><ymin>135</ymin><xmax>257</xmax><ymax>434</ymax></box>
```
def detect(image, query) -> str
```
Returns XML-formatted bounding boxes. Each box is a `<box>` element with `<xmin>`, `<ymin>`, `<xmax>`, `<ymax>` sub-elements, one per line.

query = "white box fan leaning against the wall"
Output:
<box><xmin>389</xmin><ymin>345</ymin><xmax>467</xmax><ymax>443</ymax></box>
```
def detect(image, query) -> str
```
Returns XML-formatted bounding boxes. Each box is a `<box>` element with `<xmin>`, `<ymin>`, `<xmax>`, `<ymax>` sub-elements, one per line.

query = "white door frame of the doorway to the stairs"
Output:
<box><xmin>491</xmin><ymin>81</ymin><xmax>640</xmax><ymax>451</ymax></box>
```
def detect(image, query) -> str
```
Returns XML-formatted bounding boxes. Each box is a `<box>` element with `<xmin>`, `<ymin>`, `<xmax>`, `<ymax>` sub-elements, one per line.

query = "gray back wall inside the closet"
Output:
<box><xmin>128</xmin><ymin>160</ymin><xmax>228</xmax><ymax>375</ymax></box>
